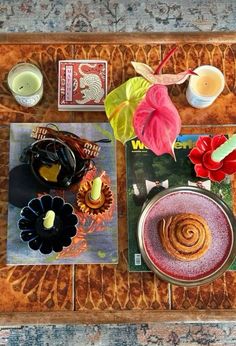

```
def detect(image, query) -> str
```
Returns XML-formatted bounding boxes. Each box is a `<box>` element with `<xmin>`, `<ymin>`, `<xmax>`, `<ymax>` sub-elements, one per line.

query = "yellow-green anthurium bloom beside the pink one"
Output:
<box><xmin>104</xmin><ymin>77</ymin><xmax>151</xmax><ymax>144</ymax></box>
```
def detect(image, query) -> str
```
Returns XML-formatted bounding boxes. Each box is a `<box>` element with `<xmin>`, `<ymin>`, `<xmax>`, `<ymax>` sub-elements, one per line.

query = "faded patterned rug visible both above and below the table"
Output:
<box><xmin>0</xmin><ymin>0</ymin><xmax>236</xmax><ymax>346</ymax></box>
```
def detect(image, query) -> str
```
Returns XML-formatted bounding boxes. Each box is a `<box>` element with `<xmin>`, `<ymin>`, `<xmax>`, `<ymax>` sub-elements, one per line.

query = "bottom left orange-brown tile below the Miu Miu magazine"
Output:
<box><xmin>0</xmin><ymin>265</ymin><xmax>73</xmax><ymax>312</ymax></box>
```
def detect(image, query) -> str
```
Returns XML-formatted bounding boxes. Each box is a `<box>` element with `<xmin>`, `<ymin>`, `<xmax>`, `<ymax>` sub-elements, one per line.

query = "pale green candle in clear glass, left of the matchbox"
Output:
<box><xmin>7</xmin><ymin>63</ymin><xmax>43</xmax><ymax>107</ymax></box>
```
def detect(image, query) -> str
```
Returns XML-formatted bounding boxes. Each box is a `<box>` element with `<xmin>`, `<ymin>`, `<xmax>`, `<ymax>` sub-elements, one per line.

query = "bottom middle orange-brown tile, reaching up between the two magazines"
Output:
<box><xmin>75</xmin><ymin>218</ymin><xmax>169</xmax><ymax>311</ymax></box>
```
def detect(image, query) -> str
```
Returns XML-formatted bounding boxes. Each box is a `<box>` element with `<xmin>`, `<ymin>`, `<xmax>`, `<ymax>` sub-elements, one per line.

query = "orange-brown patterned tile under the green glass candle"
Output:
<box><xmin>0</xmin><ymin>45</ymin><xmax>73</xmax><ymax>124</ymax></box>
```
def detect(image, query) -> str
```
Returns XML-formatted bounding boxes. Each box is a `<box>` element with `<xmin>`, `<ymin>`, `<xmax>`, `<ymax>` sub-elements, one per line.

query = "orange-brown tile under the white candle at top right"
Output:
<box><xmin>162</xmin><ymin>43</ymin><xmax>236</xmax><ymax>125</ymax></box>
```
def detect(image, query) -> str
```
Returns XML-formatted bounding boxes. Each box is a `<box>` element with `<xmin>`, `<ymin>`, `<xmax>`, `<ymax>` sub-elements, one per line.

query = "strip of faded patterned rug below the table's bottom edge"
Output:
<box><xmin>0</xmin><ymin>323</ymin><xmax>236</xmax><ymax>346</ymax></box>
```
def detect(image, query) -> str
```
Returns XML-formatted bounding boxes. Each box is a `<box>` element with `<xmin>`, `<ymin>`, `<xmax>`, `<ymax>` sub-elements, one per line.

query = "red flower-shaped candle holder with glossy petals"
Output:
<box><xmin>189</xmin><ymin>135</ymin><xmax>236</xmax><ymax>182</ymax></box>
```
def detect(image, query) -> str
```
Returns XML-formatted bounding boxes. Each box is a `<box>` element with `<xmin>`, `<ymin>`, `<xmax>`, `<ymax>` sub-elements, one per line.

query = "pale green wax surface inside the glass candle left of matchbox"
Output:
<box><xmin>12</xmin><ymin>71</ymin><xmax>40</xmax><ymax>96</ymax></box>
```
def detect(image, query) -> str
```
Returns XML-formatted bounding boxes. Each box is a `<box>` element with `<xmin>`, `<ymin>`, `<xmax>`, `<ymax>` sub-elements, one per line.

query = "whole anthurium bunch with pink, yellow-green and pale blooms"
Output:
<box><xmin>104</xmin><ymin>47</ymin><xmax>196</xmax><ymax>156</ymax></box>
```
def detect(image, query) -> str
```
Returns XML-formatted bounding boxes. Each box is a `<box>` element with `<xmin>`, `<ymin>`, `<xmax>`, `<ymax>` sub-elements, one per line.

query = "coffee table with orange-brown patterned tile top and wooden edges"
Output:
<box><xmin>0</xmin><ymin>33</ymin><xmax>236</xmax><ymax>325</ymax></box>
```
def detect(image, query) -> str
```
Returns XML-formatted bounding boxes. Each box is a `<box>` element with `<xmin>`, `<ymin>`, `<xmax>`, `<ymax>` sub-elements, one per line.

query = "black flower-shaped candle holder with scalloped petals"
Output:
<box><xmin>18</xmin><ymin>195</ymin><xmax>78</xmax><ymax>255</ymax></box>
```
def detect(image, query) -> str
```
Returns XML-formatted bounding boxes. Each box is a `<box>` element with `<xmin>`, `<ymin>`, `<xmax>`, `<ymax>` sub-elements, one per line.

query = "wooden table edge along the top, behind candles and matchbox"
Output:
<box><xmin>0</xmin><ymin>31</ymin><xmax>236</xmax><ymax>44</ymax></box>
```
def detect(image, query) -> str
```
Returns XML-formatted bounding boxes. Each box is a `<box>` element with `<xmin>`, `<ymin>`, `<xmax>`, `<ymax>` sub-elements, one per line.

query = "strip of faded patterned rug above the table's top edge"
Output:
<box><xmin>0</xmin><ymin>0</ymin><xmax>236</xmax><ymax>32</ymax></box>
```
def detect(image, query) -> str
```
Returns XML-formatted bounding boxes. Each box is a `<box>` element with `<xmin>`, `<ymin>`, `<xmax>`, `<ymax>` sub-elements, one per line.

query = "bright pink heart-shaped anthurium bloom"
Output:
<box><xmin>133</xmin><ymin>85</ymin><xmax>181</xmax><ymax>156</ymax></box>
